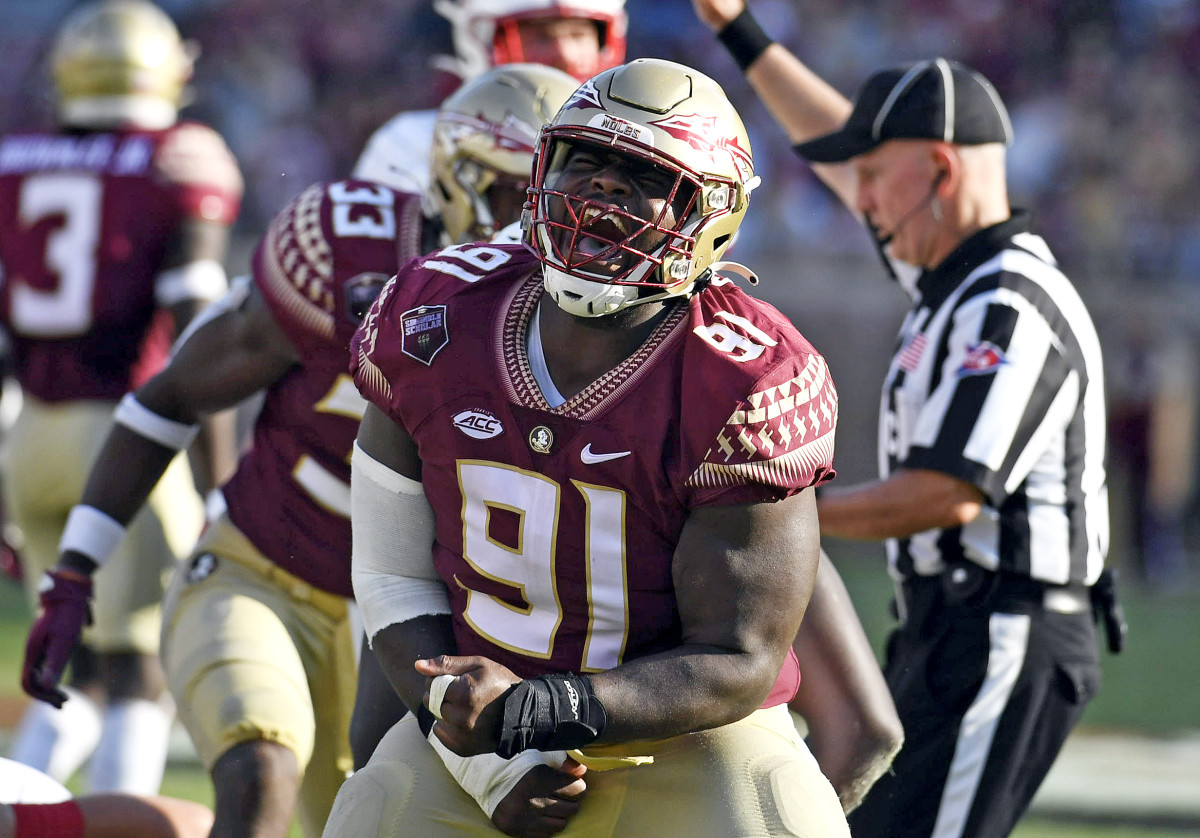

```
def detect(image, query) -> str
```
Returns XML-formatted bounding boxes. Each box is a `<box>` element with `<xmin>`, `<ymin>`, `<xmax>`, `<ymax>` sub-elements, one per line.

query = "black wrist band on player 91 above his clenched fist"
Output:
<box><xmin>496</xmin><ymin>672</ymin><xmax>608</xmax><ymax>760</ymax></box>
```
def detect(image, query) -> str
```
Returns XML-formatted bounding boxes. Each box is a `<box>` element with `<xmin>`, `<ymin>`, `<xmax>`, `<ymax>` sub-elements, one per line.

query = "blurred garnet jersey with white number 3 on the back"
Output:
<box><xmin>0</xmin><ymin>122</ymin><xmax>241</xmax><ymax>402</ymax></box>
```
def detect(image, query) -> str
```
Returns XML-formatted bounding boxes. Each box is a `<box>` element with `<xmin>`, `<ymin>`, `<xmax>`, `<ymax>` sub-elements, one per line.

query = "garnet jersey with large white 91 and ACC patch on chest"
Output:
<box><xmin>352</xmin><ymin>245</ymin><xmax>838</xmax><ymax>704</ymax></box>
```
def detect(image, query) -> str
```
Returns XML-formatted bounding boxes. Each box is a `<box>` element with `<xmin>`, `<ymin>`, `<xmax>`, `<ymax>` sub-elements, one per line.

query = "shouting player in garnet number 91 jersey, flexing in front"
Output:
<box><xmin>325</xmin><ymin>59</ymin><xmax>848</xmax><ymax>838</ymax></box>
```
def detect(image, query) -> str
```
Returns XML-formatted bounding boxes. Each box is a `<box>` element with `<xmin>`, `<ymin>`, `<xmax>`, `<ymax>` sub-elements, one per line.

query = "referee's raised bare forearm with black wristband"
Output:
<box><xmin>692</xmin><ymin>0</ymin><xmax>854</xmax><ymax>210</ymax></box>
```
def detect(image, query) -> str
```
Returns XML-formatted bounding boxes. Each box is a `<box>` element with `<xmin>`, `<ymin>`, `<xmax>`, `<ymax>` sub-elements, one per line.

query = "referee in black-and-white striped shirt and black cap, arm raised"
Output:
<box><xmin>694</xmin><ymin>0</ymin><xmax>1123</xmax><ymax>838</ymax></box>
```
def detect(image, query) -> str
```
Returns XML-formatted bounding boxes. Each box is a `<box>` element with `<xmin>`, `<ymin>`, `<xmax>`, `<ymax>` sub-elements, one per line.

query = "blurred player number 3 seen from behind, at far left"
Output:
<box><xmin>0</xmin><ymin>0</ymin><xmax>242</xmax><ymax>794</ymax></box>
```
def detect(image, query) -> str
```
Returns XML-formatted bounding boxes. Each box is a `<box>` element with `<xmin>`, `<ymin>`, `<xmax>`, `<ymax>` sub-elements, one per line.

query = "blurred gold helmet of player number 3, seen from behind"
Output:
<box><xmin>50</xmin><ymin>0</ymin><xmax>197</xmax><ymax>128</ymax></box>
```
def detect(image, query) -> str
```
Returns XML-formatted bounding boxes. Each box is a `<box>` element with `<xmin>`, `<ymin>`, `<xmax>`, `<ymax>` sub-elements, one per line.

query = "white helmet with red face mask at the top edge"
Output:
<box><xmin>433</xmin><ymin>0</ymin><xmax>629</xmax><ymax>82</ymax></box>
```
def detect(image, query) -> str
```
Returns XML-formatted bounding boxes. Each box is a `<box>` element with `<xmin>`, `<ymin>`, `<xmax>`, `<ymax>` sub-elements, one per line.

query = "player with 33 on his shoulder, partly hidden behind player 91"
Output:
<box><xmin>25</xmin><ymin>65</ymin><xmax>576</xmax><ymax>838</ymax></box>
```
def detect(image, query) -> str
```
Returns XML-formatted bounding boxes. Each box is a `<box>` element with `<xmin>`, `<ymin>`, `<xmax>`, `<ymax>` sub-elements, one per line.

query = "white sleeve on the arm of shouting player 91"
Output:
<box><xmin>350</xmin><ymin>443</ymin><xmax>450</xmax><ymax>642</ymax></box>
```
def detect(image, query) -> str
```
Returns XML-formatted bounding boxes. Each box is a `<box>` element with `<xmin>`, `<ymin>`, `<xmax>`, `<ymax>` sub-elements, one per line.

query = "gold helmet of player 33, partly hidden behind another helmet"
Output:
<box><xmin>428</xmin><ymin>64</ymin><xmax>577</xmax><ymax>245</ymax></box>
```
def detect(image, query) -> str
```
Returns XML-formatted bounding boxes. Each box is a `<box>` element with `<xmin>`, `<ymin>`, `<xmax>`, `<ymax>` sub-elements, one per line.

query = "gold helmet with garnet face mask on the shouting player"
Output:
<box><xmin>526</xmin><ymin>59</ymin><xmax>758</xmax><ymax>317</ymax></box>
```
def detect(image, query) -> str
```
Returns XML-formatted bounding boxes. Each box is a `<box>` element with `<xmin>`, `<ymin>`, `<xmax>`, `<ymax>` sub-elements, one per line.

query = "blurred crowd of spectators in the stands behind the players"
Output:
<box><xmin>0</xmin><ymin>0</ymin><xmax>1200</xmax><ymax>583</ymax></box>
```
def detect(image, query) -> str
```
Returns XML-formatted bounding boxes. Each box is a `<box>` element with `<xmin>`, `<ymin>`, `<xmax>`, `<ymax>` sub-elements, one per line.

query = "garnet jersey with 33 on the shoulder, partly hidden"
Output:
<box><xmin>224</xmin><ymin>180</ymin><xmax>424</xmax><ymax>597</ymax></box>
